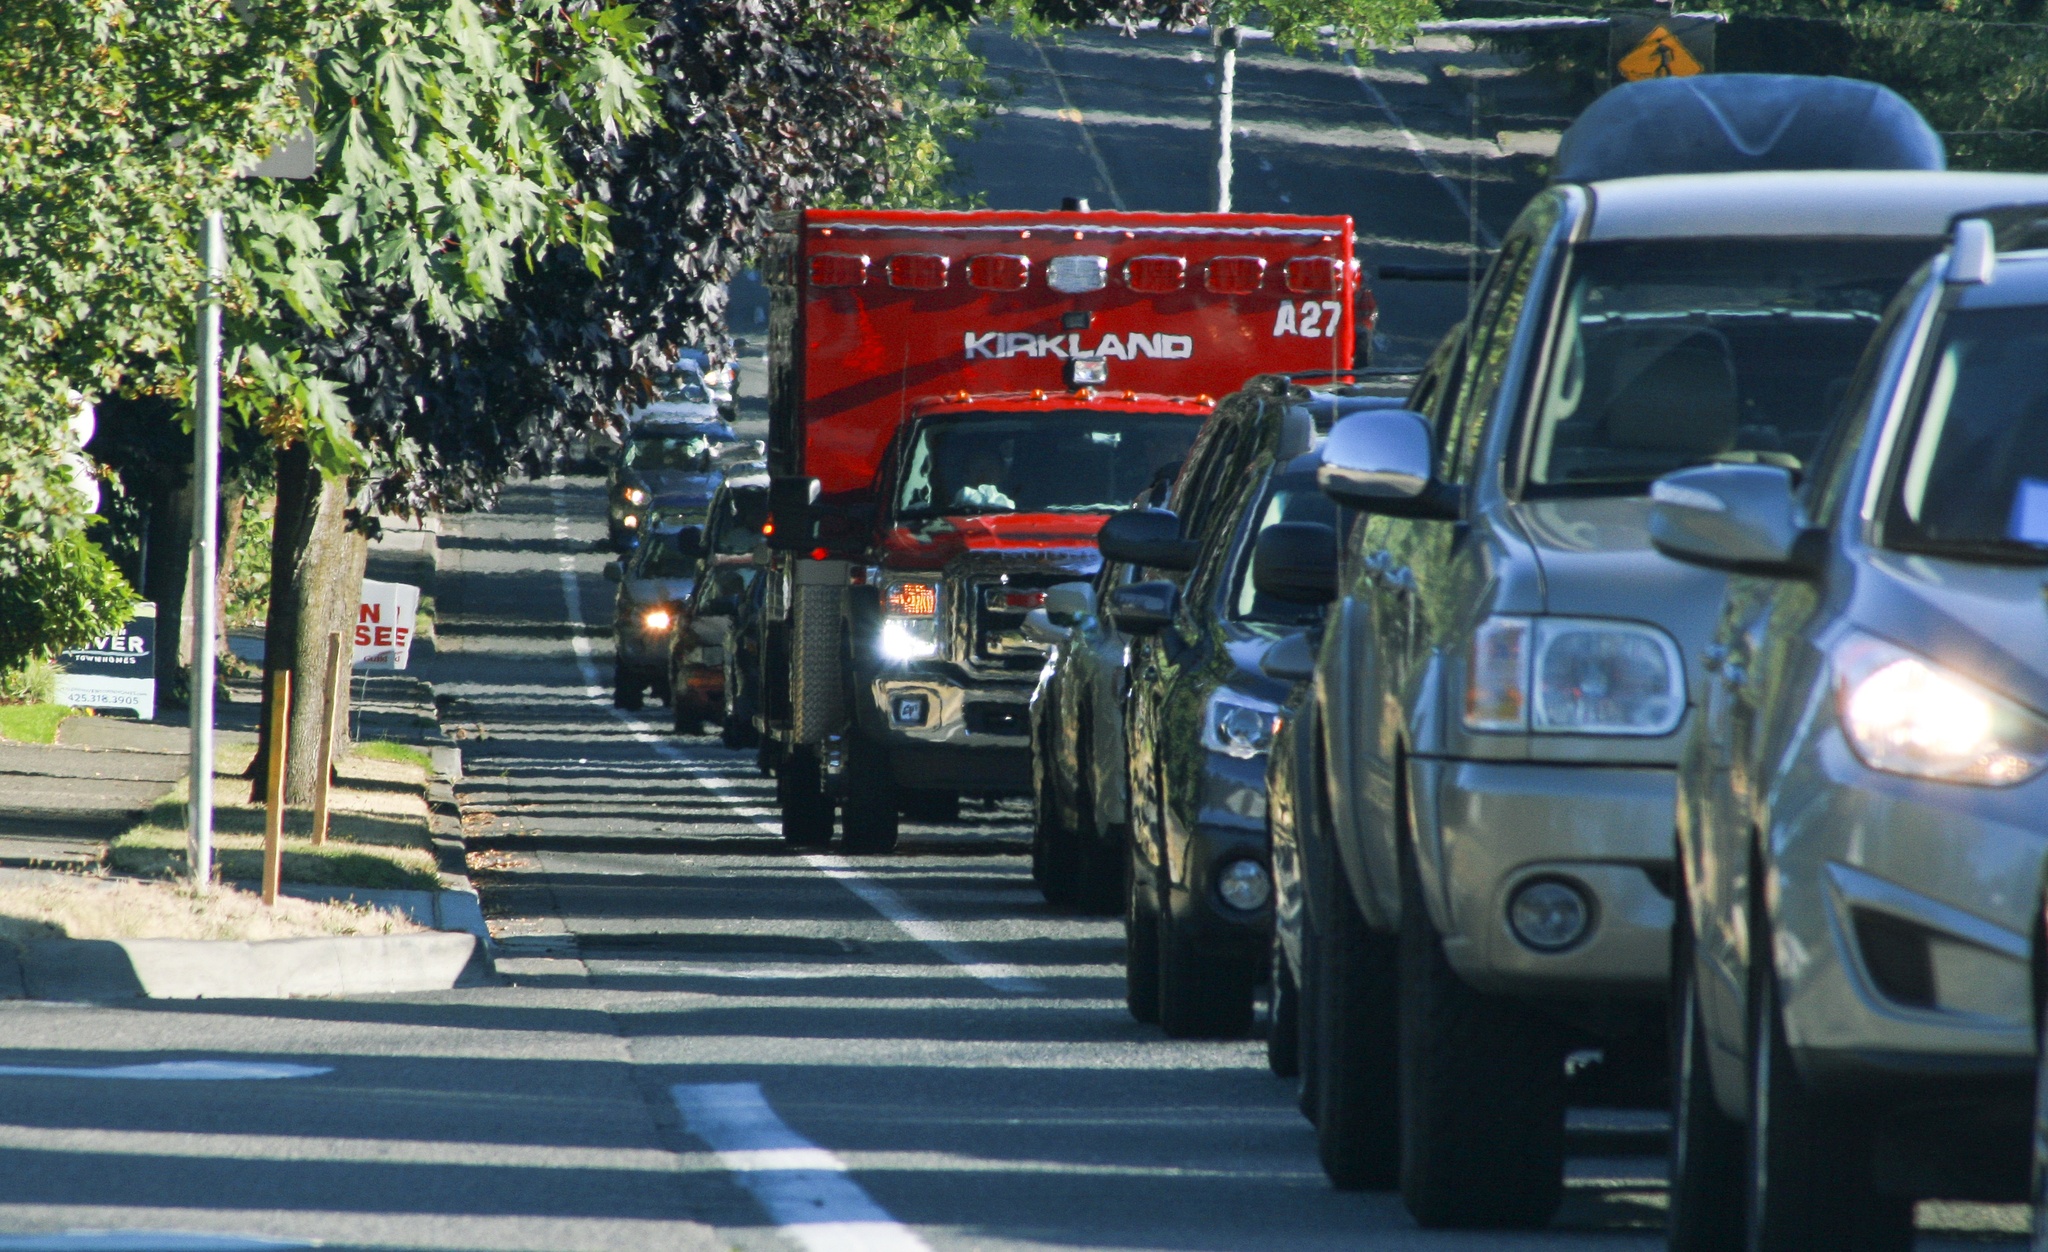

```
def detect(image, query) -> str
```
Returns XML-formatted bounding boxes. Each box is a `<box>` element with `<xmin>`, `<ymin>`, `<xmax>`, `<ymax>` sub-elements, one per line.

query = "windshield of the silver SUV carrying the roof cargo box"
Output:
<box><xmin>1526</xmin><ymin>240</ymin><xmax>1937</xmax><ymax>496</ymax></box>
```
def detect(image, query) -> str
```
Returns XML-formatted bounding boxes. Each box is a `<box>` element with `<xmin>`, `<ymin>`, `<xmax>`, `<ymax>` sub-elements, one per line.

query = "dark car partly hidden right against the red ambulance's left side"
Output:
<box><xmin>670</xmin><ymin>471</ymin><xmax>768</xmax><ymax>740</ymax></box>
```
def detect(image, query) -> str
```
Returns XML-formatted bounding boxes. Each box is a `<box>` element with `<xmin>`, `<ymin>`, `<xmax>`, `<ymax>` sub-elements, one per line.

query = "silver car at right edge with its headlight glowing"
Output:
<box><xmin>1649</xmin><ymin>213</ymin><xmax>2048</xmax><ymax>1252</ymax></box>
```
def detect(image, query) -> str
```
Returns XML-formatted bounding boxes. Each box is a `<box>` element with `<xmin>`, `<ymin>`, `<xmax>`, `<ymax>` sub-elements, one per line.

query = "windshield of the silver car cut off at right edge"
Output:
<box><xmin>1884</xmin><ymin>307</ymin><xmax>2048</xmax><ymax>564</ymax></box>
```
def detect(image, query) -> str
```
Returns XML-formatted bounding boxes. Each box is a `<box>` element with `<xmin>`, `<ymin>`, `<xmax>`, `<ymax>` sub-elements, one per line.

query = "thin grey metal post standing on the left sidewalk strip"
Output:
<box><xmin>184</xmin><ymin>211</ymin><xmax>227</xmax><ymax>891</ymax></box>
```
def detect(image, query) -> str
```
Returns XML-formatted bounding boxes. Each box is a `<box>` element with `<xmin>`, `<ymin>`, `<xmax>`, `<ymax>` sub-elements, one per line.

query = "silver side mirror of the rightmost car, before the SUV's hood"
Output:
<box><xmin>1651</xmin><ymin>465</ymin><xmax>1827</xmax><ymax>578</ymax></box>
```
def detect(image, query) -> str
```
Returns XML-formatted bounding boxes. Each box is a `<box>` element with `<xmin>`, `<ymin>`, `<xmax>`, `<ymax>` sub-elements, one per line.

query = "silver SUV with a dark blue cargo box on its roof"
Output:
<box><xmin>1292</xmin><ymin>74</ymin><xmax>2042</xmax><ymax>1227</ymax></box>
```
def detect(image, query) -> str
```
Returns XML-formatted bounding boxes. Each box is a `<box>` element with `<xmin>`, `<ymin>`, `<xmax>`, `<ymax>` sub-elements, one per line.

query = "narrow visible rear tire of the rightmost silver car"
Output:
<box><xmin>1665</xmin><ymin>883</ymin><xmax>1745</xmax><ymax>1252</ymax></box>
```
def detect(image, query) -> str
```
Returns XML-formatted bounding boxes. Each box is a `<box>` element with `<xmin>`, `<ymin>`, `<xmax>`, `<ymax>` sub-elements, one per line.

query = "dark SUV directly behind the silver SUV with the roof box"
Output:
<box><xmin>1100</xmin><ymin>377</ymin><xmax>1335</xmax><ymax>1037</ymax></box>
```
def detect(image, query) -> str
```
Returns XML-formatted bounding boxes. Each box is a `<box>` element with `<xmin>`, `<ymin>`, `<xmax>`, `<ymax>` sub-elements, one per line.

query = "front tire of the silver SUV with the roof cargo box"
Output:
<box><xmin>1399</xmin><ymin>854</ymin><xmax>1565</xmax><ymax>1229</ymax></box>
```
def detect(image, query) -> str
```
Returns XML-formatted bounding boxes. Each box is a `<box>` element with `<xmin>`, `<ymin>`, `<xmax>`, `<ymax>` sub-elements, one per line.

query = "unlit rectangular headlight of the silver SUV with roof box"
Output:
<box><xmin>1464</xmin><ymin>617</ymin><xmax>1686</xmax><ymax>736</ymax></box>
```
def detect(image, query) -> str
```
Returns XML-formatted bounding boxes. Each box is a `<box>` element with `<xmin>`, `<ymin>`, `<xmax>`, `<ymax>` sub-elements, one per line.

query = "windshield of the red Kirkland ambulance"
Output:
<box><xmin>895</xmin><ymin>410</ymin><xmax>1204</xmax><ymax>518</ymax></box>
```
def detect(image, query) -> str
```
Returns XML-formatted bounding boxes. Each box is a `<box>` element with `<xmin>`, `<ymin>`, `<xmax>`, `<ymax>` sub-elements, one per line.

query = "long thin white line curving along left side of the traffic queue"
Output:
<box><xmin>549</xmin><ymin>473</ymin><xmax>1047</xmax><ymax>996</ymax></box>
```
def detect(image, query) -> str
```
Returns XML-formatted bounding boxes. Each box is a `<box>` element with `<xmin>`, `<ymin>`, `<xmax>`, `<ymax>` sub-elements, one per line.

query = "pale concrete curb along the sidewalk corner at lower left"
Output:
<box><xmin>0</xmin><ymin>932</ymin><xmax>494</xmax><ymax>1000</ymax></box>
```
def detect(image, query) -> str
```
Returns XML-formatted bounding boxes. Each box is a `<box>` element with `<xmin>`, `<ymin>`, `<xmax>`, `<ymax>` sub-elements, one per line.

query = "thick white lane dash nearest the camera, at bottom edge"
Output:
<box><xmin>670</xmin><ymin>1082</ymin><xmax>930</xmax><ymax>1252</ymax></box>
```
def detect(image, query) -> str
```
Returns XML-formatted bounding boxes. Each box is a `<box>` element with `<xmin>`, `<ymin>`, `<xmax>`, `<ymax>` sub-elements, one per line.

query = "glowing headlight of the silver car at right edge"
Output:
<box><xmin>1831</xmin><ymin>635</ymin><xmax>2048</xmax><ymax>787</ymax></box>
